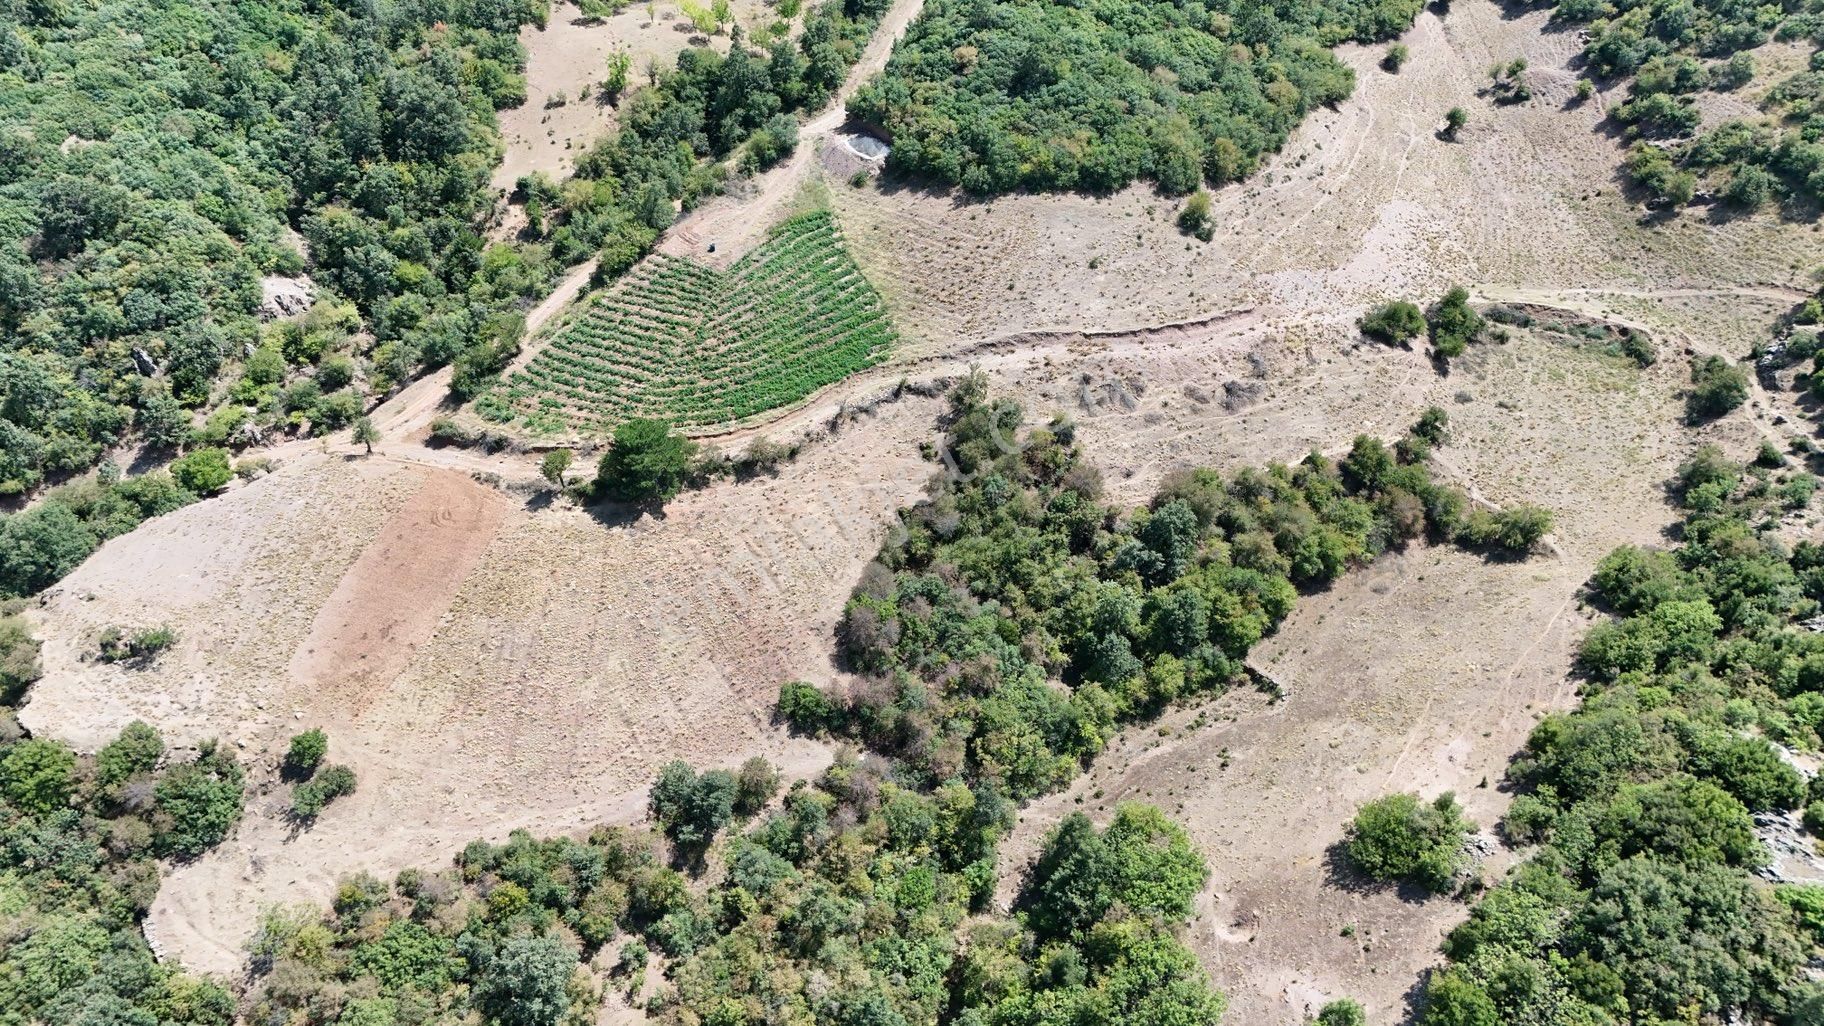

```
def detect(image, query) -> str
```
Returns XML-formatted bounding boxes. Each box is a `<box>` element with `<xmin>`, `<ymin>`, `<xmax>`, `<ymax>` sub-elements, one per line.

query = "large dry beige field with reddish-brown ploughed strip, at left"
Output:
<box><xmin>26</xmin><ymin>400</ymin><xmax>936</xmax><ymax>973</ymax></box>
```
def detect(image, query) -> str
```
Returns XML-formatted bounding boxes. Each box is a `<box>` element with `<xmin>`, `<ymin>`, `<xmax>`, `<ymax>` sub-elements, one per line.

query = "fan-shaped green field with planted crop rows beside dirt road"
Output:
<box><xmin>482</xmin><ymin>212</ymin><xmax>894</xmax><ymax>434</ymax></box>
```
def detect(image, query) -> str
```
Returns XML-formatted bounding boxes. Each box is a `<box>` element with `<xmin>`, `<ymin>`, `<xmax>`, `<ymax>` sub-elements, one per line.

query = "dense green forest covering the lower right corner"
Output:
<box><xmin>1423</xmin><ymin>447</ymin><xmax>1824</xmax><ymax>1026</ymax></box>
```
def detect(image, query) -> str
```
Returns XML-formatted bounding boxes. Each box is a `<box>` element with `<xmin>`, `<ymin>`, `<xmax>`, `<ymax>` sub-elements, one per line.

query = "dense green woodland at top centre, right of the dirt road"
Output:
<box><xmin>848</xmin><ymin>0</ymin><xmax>1421</xmax><ymax>194</ymax></box>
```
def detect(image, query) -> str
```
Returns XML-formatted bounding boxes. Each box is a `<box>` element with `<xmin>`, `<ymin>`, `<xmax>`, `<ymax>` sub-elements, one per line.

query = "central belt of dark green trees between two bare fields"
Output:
<box><xmin>781</xmin><ymin>378</ymin><xmax>1549</xmax><ymax>798</ymax></box>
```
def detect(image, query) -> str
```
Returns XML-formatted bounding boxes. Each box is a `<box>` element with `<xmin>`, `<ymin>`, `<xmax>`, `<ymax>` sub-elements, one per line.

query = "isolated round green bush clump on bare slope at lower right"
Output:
<box><xmin>1344</xmin><ymin>790</ymin><xmax>1476</xmax><ymax>893</ymax></box>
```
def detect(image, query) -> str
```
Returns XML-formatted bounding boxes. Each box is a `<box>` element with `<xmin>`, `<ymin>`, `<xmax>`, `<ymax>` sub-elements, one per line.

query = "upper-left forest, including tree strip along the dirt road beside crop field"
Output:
<box><xmin>0</xmin><ymin>0</ymin><xmax>901</xmax><ymax>595</ymax></box>
